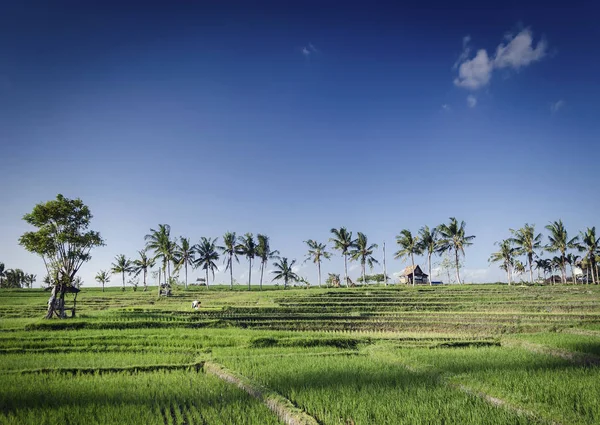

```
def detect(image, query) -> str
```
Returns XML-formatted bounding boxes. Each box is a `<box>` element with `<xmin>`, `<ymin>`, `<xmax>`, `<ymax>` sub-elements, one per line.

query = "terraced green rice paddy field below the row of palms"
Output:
<box><xmin>0</xmin><ymin>285</ymin><xmax>600</xmax><ymax>425</ymax></box>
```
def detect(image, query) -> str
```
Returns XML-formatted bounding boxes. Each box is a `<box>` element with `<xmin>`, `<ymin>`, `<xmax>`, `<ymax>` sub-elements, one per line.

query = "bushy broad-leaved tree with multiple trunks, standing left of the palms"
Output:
<box><xmin>19</xmin><ymin>194</ymin><xmax>104</xmax><ymax>318</ymax></box>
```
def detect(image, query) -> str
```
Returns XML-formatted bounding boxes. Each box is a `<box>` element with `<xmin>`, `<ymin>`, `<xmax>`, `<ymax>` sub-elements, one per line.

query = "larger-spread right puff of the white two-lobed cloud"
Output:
<box><xmin>494</xmin><ymin>28</ymin><xmax>547</xmax><ymax>69</ymax></box>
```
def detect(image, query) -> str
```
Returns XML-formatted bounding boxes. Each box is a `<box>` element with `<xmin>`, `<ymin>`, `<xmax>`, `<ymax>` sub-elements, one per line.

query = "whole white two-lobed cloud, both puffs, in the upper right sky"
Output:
<box><xmin>453</xmin><ymin>28</ymin><xmax>548</xmax><ymax>90</ymax></box>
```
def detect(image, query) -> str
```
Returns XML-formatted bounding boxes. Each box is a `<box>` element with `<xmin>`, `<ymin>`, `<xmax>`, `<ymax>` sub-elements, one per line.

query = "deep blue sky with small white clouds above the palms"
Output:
<box><xmin>0</xmin><ymin>1</ymin><xmax>600</xmax><ymax>285</ymax></box>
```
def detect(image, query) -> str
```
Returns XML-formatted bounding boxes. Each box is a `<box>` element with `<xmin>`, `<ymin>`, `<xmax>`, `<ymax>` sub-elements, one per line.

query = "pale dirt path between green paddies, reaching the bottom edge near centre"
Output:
<box><xmin>204</xmin><ymin>362</ymin><xmax>319</xmax><ymax>425</ymax></box>
